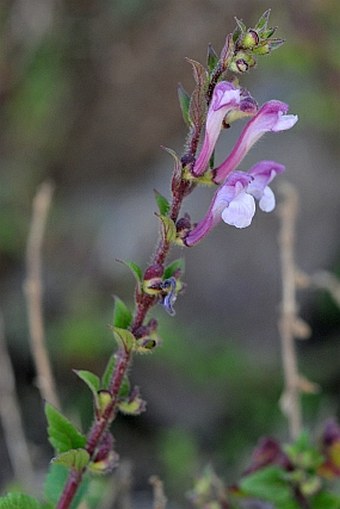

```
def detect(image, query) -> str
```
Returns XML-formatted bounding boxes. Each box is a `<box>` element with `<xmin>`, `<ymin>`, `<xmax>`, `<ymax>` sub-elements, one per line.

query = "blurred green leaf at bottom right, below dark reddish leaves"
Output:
<box><xmin>240</xmin><ymin>466</ymin><xmax>299</xmax><ymax>509</ymax></box>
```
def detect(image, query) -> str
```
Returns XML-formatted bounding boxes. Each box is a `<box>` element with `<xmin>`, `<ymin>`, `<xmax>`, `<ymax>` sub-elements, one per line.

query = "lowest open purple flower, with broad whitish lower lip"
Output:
<box><xmin>185</xmin><ymin>161</ymin><xmax>285</xmax><ymax>247</ymax></box>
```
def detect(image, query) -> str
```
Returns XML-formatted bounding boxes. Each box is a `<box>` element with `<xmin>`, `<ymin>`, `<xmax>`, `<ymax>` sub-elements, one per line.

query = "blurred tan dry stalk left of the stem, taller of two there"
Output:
<box><xmin>24</xmin><ymin>182</ymin><xmax>60</xmax><ymax>408</ymax></box>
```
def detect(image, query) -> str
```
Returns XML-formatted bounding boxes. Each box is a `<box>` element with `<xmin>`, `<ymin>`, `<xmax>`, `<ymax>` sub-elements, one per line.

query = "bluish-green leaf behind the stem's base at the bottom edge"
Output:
<box><xmin>44</xmin><ymin>463</ymin><xmax>89</xmax><ymax>509</ymax></box>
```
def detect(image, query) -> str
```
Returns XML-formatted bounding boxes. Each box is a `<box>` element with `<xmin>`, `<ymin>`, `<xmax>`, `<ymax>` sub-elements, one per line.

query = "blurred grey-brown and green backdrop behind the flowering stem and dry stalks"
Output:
<box><xmin>0</xmin><ymin>0</ymin><xmax>340</xmax><ymax>499</ymax></box>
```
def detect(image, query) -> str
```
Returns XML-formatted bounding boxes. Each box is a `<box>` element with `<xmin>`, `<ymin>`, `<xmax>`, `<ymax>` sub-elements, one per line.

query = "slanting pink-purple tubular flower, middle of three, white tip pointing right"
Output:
<box><xmin>213</xmin><ymin>100</ymin><xmax>298</xmax><ymax>184</ymax></box>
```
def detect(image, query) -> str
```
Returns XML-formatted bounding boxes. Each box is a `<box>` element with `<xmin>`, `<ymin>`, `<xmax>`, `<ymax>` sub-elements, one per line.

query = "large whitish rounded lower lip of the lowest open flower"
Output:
<box><xmin>222</xmin><ymin>190</ymin><xmax>255</xmax><ymax>228</ymax></box>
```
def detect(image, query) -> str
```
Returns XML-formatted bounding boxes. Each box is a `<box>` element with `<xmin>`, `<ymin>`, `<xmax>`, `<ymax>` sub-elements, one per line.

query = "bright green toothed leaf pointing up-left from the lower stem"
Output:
<box><xmin>45</xmin><ymin>403</ymin><xmax>86</xmax><ymax>453</ymax></box>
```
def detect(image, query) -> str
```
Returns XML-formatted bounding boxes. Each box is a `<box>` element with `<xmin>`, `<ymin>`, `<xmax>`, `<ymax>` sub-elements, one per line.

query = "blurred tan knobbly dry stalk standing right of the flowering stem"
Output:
<box><xmin>279</xmin><ymin>183</ymin><xmax>302</xmax><ymax>439</ymax></box>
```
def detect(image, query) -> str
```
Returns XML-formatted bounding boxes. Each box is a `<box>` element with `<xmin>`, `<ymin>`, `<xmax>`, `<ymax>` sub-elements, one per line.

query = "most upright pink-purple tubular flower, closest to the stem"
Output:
<box><xmin>192</xmin><ymin>81</ymin><xmax>240</xmax><ymax>176</ymax></box>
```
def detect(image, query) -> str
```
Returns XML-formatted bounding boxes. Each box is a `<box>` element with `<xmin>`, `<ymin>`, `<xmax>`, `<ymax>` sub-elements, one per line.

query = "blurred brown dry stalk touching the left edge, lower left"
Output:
<box><xmin>0</xmin><ymin>312</ymin><xmax>33</xmax><ymax>486</ymax></box>
